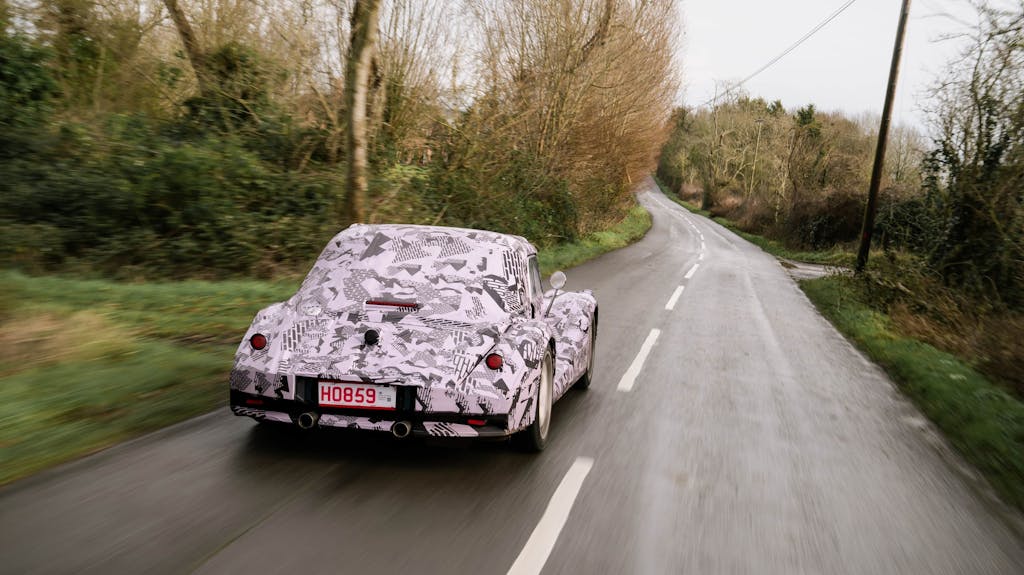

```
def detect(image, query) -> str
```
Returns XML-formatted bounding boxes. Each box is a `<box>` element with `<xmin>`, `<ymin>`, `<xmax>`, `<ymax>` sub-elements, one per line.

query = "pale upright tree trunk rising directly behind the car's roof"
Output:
<box><xmin>339</xmin><ymin>0</ymin><xmax>380</xmax><ymax>223</ymax></box>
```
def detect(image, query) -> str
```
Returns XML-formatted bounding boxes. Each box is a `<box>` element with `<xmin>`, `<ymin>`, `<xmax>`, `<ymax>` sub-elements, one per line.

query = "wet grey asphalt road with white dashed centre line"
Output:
<box><xmin>0</xmin><ymin>177</ymin><xmax>1024</xmax><ymax>574</ymax></box>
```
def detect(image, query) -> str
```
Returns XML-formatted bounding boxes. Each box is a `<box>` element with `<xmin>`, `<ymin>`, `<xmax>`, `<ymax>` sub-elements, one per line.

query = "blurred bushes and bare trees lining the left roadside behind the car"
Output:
<box><xmin>0</xmin><ymin>0</ymin><xmax>676</xmax><ymax>280</ymax></box>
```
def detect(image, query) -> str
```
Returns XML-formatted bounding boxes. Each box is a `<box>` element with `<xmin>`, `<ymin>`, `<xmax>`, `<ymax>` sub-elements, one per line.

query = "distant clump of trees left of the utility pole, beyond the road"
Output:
<box><xmin>657</xmin><ymin>96</ymin><xmax>892</xmax><ymax>250</ymax></box>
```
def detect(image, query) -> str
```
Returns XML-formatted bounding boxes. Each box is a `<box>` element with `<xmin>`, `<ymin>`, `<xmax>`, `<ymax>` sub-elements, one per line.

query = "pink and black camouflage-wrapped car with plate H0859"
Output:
<box><xmin>230</xmin><ymin>224</ymin><xmax>598</xmax><ymax>451</ymax></box>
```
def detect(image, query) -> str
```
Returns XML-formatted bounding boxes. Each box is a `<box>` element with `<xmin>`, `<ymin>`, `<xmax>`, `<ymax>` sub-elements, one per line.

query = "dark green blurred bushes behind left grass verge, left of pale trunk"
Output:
<box><xmin>0</xmin><ymin>117</ymin><xmax>344</xmax><ymax>277</ymax></box>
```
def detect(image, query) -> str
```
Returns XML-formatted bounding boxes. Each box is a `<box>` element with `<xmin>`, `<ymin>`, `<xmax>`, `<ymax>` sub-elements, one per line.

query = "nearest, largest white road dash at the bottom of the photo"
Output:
<box><xmin>509</xmin><ymin>457</ymin><xmax>594</xmax><ymax>575</ymax></box>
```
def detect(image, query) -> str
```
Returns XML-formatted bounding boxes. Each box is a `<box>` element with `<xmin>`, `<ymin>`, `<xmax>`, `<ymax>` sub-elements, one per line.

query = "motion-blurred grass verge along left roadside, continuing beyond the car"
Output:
<box><xmin>0</xmin><ymin>201</ymin><xmax>650</xmax><ymax>485</ymax></box>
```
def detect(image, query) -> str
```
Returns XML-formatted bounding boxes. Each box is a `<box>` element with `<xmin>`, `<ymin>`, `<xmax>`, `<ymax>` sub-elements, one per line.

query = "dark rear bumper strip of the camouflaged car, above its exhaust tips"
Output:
<box><xmin>230</xmin><ymin>391</ymin><xmax>511</xmax><ymax>438</ymax></box>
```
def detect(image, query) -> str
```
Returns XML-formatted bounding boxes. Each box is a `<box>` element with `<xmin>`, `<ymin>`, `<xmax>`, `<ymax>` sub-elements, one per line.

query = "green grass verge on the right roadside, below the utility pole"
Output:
<box><xmin>801</xmin><ymin>276</ymin><xmax>1024</xmax><ymax>508</ymax></box>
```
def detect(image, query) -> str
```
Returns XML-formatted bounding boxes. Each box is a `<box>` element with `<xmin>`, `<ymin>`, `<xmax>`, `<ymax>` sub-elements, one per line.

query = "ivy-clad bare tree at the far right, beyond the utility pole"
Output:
<box><xmin>919</xmin><ymin>4</ymin><xmax>1024</xmax><ymax>306</ymax></box>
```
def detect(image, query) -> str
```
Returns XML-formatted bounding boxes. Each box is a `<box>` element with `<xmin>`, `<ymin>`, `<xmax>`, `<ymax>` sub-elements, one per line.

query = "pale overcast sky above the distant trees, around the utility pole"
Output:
<box><xmin>680</xmin><ymin>0</ymin><xmax>975</xmax><ymax>129</ymax></box>
